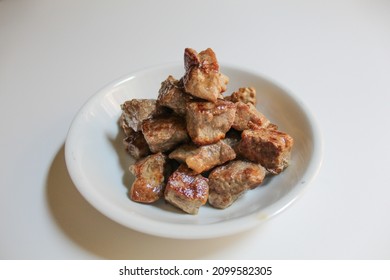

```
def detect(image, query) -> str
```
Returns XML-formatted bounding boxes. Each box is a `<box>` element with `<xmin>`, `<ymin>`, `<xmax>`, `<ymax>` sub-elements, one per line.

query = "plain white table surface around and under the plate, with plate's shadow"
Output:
<box><xmin>0</xmin><ymin>0</ymin><xmax>390</xmax><ymax>259</ymax></box>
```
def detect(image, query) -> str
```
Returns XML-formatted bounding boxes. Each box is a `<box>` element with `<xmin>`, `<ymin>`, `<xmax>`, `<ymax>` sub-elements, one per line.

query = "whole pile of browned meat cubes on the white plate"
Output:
<box><xmin>120</xmin><ymin>48</ymin><xmax>293</xmax><ymax>214</ymax></box>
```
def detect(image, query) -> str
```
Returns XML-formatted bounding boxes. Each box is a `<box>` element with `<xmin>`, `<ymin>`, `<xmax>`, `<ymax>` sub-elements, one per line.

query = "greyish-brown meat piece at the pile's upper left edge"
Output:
<box><xmin>121</xmin><ymin>99</ymin><xmax>164</xmax><ymax>131</ymax></box>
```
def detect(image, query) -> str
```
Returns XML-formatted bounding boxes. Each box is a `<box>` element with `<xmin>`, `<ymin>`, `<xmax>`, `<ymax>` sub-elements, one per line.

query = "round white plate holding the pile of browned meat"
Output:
<box><xmin>65</xmin><ymin>64</ymin><xmax>322</xmax><ymax>239</ymax></box>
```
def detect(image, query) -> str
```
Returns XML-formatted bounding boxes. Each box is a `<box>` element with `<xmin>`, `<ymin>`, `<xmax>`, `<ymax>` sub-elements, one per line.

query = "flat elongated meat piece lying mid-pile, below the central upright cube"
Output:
<box><xmin>169</xmin><ymin>141</ymin><xmax>236</xmax><ymax>173</ymax></box>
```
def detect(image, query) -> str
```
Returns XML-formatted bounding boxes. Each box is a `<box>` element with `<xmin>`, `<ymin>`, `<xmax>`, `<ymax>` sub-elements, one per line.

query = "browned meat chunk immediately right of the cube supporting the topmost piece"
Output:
<box><xmin>232</xmin><ymin>101</ymin><xmax>270</xmax><ymax>131</ymax></box>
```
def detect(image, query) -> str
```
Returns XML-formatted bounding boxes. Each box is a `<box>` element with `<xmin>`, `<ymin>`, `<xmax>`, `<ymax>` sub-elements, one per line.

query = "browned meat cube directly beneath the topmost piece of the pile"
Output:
<box><xmin>186</xmin><ymin>99</ymin><xmax>236</xmax><ymax>145</ymax></box>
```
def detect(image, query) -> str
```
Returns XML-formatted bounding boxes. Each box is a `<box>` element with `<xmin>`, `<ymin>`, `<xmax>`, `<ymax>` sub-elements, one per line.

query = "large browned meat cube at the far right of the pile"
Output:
<box><xmin>238</xmin><ymin>128</ymin><xmax>294</xmax><ymax>174</ymax></box>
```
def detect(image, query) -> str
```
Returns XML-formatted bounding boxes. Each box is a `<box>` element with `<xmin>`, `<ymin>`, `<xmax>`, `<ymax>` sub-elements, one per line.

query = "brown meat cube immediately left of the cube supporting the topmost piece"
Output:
<box><xmin>142</xmin><ymin>116</ymin><xmax>189</xmax><ymax>153</ymax></box>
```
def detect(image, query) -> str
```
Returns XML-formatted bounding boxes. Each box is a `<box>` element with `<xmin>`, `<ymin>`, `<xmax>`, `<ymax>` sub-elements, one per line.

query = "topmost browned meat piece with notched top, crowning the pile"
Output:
<box><xmin>183</xmin><ymin>48</ymin><xmax>229</xmax><ymax>102</ymax></box>
